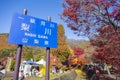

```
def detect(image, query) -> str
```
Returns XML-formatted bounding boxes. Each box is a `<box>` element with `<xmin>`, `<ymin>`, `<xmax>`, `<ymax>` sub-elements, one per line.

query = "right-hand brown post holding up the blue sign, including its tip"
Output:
<box><xmin>46</xmin><ymin>16</ymin><xmax>51</xmax><ymax>80</ymax></box>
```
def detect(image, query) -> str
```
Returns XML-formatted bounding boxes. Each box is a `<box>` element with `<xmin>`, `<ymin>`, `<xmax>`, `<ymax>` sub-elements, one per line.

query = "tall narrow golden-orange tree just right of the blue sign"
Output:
<box><xmin>51</xmin><ymin>24</ymin><xmax>70</xmax><ymax>66</ymax></box>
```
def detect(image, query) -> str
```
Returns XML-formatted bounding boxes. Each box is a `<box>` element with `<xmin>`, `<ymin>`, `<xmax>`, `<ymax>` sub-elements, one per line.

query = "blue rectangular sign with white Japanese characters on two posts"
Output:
<box><xmin>8</xmin><ymin>13</ymin><xmax>58</xmax><ymax>48</ymax></box>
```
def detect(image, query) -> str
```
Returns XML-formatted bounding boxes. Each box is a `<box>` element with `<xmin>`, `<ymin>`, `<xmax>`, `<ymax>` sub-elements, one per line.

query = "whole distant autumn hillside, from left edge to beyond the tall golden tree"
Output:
<box><xmin>0</xmin><ymin>33</ymin><xmax>89</xmax><ymax>59</ymax></box>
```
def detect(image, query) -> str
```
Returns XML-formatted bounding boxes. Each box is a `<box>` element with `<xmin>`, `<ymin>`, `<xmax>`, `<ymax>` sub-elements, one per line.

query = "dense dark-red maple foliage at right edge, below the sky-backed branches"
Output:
<box><xmin>91</xmin><ymin>26</ymin><xmax>120</xmax><ymax>66</ymax></box>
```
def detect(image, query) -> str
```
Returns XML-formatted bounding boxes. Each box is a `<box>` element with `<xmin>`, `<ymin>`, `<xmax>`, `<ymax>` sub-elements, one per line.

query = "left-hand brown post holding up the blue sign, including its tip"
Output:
<box><xmin>13</xmin><ymin>9</ymin><xmax>27</xmax><ymax>80</ymax></box>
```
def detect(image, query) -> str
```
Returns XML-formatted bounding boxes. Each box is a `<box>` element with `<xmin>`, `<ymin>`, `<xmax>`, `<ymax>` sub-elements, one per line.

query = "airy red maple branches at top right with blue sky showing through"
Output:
<box><xmin>61</xmin><ymin>0</ymin><xmax>120</xmax><ymax>37</ymax></box>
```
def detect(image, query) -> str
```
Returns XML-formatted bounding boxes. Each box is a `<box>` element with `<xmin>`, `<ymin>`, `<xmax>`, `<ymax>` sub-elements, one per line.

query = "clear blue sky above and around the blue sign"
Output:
<box><xmin>0</xmin><ymin>0</ymin><xmax>88</xmax><ymax>40</ymax></box>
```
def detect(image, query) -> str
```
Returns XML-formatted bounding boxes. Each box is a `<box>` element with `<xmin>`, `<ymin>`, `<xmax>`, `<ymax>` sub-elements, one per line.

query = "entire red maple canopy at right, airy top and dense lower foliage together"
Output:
<box><xmin>61</xmin><ymin>0</ymin><xmax>120</xmax><ymax>65</ymax></box>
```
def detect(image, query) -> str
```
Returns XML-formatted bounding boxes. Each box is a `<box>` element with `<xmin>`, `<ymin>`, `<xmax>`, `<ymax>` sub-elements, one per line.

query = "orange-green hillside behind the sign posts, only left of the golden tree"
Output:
<box><xmin>0</xmin><ymin>33</ymin><xmax>45</xmax><ymax>59</ymax></box>
